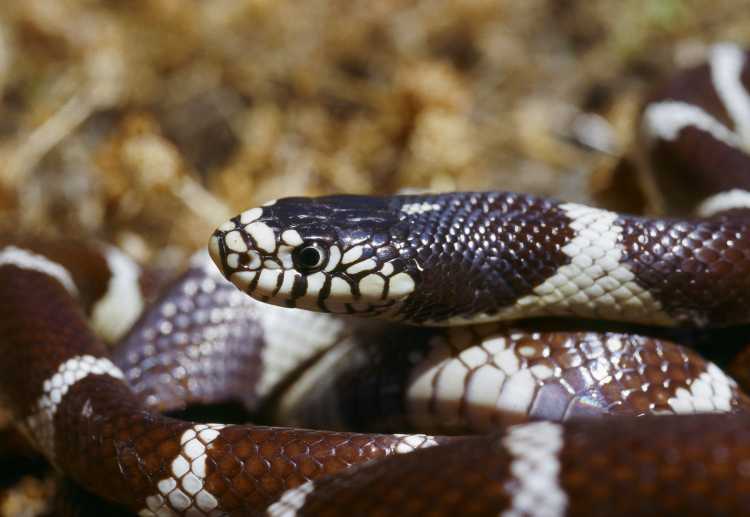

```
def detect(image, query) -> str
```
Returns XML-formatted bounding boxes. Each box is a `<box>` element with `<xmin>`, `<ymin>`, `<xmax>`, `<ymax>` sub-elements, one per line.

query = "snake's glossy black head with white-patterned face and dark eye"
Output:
<box><xmin>209</xmin><ymin>195</ymin><xmax>419</xmax><ymax>316</ymax></box>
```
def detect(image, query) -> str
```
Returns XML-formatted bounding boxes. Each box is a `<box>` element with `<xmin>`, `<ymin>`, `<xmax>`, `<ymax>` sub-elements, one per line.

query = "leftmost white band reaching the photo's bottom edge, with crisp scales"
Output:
<box><xmin>139</xmin><ymin>424</ymin><xmax>226</xmax><ymax>517</ymax></box>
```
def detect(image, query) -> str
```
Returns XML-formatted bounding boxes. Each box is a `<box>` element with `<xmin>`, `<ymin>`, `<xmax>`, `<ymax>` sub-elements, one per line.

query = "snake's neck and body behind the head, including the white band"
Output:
<box><xmin>394</xmin><ymin>192</ymin><xmax>750</xmax><ymax>326</ymax></box>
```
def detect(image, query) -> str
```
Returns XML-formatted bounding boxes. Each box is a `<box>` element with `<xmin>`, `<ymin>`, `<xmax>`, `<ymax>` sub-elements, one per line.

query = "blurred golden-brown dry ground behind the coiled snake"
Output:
<box><xmin>0</xmin><ymin>0</ymin><xmax>750</xmax><ymax>515</ymax></box>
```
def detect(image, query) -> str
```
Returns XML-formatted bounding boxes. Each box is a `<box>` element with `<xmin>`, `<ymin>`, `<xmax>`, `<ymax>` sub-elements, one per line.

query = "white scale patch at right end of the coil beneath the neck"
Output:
<box><xmin>668</xmin><ymin>363</ymin><xmax>737</xmax><ymax>413</ymax></box>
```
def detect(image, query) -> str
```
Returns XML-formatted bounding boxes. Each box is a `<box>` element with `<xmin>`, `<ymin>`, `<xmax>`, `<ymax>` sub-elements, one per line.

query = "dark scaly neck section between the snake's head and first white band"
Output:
<box><xmin>395</xmin><ymin>192</ymin><xmax>573</xmax><ymax>324</ymax></box>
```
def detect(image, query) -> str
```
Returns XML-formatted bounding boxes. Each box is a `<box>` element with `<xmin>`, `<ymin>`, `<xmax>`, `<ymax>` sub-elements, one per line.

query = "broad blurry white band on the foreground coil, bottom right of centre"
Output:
<box><xmin>501</xmin><ymin>422</ymin><xmax>568</xmax><ymax>517</ymax></box>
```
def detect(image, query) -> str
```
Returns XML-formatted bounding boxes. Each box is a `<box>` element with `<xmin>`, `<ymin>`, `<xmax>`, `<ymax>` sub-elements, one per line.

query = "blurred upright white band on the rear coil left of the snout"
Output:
<box><xmin>91</xmin><ymin>246</ymin><xmax>145</xmax><ymax>341</ymax></box>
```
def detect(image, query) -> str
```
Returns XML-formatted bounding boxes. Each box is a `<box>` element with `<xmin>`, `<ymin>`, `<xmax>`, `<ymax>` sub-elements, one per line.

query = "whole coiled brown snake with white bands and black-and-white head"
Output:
<box><xmin>0</xmin><ymin>44</ymin><xmax>750</xmax><ymax>516</ymax></box>
